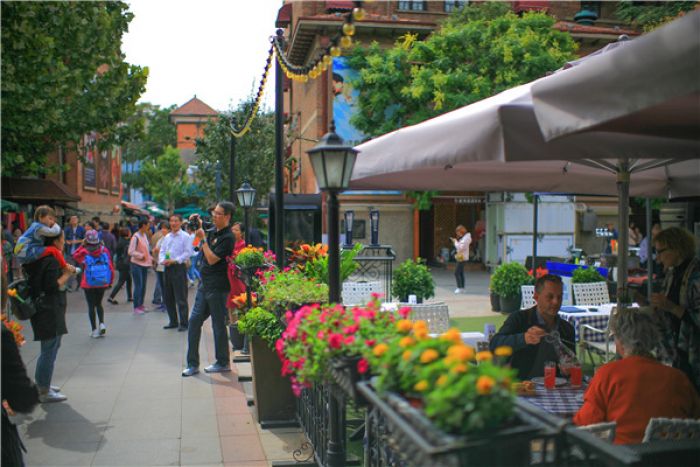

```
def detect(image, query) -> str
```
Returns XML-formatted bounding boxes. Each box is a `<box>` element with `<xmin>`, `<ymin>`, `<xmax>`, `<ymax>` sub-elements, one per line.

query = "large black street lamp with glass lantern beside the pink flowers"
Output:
<box><xmin>308</xmin><ymin>122</ymin><xmax>358</xmax><ymax>467</ymax></box>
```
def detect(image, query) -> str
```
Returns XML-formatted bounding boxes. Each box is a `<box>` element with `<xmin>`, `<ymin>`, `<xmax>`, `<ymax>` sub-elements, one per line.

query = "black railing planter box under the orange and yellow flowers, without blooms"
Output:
<box><xmin>358</xmin><ymin>382</ymin><xmax>556</xmax><ymax>467</ymax></box>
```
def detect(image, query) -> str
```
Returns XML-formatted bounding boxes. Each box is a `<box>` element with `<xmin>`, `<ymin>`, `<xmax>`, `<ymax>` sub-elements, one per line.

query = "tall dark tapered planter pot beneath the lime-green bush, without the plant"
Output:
<box><xmin>250</xmin><ymin>336</ymin><xmax>296</xmax><ymax>427</ymax></box>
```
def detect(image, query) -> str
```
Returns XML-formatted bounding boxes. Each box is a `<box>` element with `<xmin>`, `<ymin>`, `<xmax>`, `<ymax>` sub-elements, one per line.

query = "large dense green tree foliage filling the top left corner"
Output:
<box><xmin>2</xmin><ymin>1</ymin><xmax>148</xmax><ymax>175</ymax></box>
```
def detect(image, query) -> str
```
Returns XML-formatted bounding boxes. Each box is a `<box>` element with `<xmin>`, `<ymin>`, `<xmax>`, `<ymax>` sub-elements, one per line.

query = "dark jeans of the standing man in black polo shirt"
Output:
<box><xmin>187</xmin><ymin>285</ymin><xmax>230</xmax><ymax>367</ymax></box>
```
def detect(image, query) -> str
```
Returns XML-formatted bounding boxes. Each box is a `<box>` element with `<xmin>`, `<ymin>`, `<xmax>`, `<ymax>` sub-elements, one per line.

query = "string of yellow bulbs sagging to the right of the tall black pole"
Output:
<box><xmin>272</xmin><ymin>2</ymin><xmax>365</xmax><ymax>83</ymax></box>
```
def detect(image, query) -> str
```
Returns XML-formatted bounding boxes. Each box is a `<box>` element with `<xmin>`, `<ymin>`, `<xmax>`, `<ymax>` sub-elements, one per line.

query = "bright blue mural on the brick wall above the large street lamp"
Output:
<box><xmin>333</xmin><ymin>57</ymin><xmax>367</xmax><ymax>146</ymax></box>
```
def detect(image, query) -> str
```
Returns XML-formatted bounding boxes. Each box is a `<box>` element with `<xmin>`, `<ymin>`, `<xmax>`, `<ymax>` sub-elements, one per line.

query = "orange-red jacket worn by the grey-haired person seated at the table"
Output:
<box><xmin>574</xmin><ymin>355</ymin><xmax>700</xmax><ymax>444</ymax></box>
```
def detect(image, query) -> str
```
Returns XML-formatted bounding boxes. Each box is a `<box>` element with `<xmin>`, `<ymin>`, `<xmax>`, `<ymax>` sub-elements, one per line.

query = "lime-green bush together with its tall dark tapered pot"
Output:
<box><xmin>238</xmin><ymin>307</ymin><xmax>295</xmax><ymax>427</ymax></box>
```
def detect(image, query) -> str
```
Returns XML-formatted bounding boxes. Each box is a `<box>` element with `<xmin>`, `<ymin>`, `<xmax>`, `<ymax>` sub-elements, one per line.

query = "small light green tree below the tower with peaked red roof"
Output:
<box><xmin>140</xmin><ymin>146</ymin><xmax>190</xmax><ymax>214</ymax></box>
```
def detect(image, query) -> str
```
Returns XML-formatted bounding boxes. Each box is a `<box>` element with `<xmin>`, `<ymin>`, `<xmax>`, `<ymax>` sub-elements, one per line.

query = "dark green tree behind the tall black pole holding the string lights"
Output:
<box><xmin>194</xmin><ymin>101</ymin><xmax>275</xmax><ymax>212</ymax></box>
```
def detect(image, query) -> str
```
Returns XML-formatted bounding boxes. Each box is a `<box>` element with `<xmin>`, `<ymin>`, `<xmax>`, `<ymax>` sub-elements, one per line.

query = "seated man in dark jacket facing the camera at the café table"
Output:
<box><xmin>489</xmin><ymin>274</ymin><xmax>575</xmax><ymax>379</ymax></box>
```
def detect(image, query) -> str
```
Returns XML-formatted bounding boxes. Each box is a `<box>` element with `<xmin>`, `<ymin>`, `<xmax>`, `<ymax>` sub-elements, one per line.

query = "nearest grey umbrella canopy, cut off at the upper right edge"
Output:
<box><xmin>532</xmin><ymin>10</ymin><xmax>700</xmax><ymax>141</ymax></box>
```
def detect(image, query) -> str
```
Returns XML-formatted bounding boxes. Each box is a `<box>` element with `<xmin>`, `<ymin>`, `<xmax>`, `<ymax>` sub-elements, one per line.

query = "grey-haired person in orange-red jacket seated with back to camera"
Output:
<box><xmin>574</xmin><ymin>308</ymin><xmax>700</xmax><ymax>444</ymax></box>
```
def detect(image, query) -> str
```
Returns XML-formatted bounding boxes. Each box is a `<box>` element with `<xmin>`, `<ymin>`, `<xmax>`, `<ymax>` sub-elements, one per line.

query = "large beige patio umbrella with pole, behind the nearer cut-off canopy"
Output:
<box><xmin>350</xmin><ymin>77</ymin><xmax>700</xmax><ymax>306</ymax></box>
